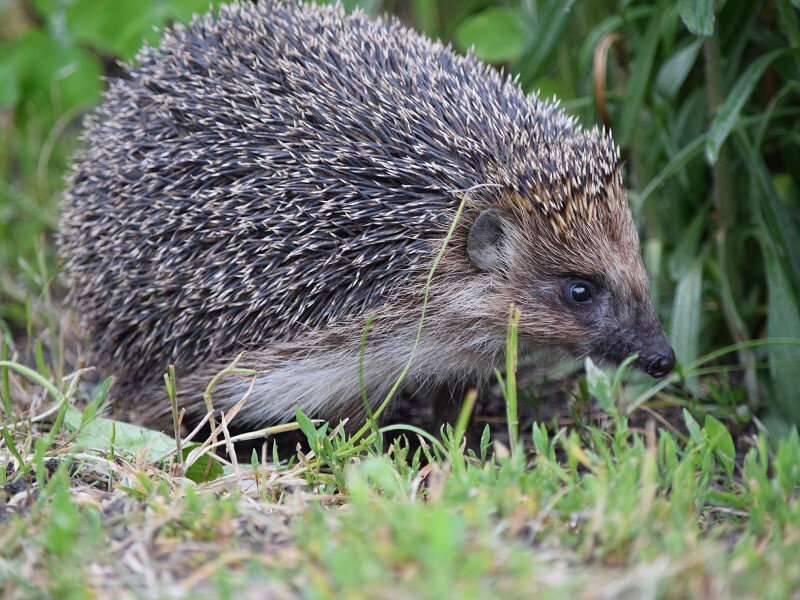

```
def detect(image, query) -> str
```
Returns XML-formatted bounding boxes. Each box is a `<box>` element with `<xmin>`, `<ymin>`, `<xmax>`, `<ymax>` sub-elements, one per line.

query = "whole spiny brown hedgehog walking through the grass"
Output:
<box><xmin>58</xmin><ymin>0</ymin><xmax>675</xmax><ymax>427</ymax></box>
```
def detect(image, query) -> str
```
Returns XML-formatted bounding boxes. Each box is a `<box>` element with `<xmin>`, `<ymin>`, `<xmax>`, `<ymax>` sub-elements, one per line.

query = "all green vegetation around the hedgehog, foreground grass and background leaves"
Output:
<box><xmin>0</xmin><ymin>0</ymin><xmax>800</xmax><ymax>599</ymax></box>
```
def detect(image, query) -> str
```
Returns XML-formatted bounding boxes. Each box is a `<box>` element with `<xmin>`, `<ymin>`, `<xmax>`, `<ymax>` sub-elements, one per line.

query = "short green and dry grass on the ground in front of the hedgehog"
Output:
<box><xmin>0</xmin><ymin>319</ymin><xmax>800</xmax><ymax>598</ymax></box>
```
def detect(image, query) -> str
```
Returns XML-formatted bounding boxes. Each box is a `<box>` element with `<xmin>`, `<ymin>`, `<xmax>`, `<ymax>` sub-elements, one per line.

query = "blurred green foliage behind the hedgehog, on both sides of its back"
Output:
<box><xmin>0</xmin><ymin>0</ymin><xmax>800</xmax><ymax>429</ymax></box>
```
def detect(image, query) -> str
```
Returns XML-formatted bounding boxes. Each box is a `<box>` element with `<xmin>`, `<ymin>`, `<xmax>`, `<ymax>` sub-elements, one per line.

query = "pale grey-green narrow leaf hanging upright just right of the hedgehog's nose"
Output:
<box><xmin>670</xmin><ymin>258</ymin><xmax>703</xmax><ymax>365</ymax></box>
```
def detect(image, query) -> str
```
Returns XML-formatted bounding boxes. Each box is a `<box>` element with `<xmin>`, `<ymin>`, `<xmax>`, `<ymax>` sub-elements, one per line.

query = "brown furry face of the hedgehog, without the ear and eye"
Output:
<box><xmin>454</xmin><ymin>151</ymin><xmax>674</xmax><ymax>374</ymax></box>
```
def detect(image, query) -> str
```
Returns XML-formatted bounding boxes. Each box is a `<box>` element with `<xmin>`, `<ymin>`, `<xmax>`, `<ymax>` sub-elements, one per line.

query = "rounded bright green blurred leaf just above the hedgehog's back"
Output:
<box><xmin>455</xmin><ymin>8</ymin><xmax>526</xmax><ymax>63</ymax></box>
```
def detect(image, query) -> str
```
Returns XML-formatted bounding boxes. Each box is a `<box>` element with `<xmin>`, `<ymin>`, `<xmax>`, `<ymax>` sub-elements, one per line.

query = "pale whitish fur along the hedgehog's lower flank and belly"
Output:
<box><xmin>141</xmin><ymin>298</ymin><xmax>503</xmax><ymax>428</ymax></box>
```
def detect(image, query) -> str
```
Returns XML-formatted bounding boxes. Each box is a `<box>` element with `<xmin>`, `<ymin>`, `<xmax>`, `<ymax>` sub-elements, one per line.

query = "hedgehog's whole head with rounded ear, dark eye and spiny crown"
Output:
<box><xmin>467</xmin><ymin>132</ymin><xmax>675</xmax><ymax>377</ymax></box>
